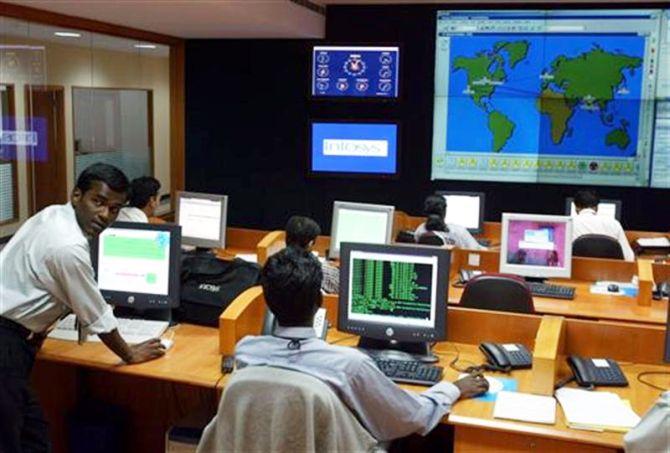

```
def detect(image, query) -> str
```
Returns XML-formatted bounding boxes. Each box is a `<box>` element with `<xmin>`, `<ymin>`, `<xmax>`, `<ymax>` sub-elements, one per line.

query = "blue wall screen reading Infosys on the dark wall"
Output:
<box><xmin>311</xmin><ymin>123</ymin><xmax>398</xmax><ymax>175</ymax></box>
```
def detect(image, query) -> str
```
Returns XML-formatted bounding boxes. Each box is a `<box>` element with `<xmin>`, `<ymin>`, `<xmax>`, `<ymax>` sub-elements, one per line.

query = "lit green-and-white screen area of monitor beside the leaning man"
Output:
<box><xmin>97</xmin><ymin>226</ymin><xmax>171</xmax><ymax>296</ymax></box>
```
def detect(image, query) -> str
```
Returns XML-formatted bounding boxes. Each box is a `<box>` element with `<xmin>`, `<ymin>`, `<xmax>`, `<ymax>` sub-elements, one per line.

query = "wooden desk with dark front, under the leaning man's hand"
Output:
<box><xmin>33</xmin><ymin>324</ymin><xmax>221</xmax><ymax>453</ymax></box>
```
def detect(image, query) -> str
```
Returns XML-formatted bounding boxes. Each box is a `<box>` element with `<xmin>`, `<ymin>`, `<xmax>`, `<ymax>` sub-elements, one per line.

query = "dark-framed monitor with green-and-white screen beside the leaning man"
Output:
<box><xmin>91</xmin><ymin>222</ymin><xmax>181</xmax><ymax>310</ymax></box>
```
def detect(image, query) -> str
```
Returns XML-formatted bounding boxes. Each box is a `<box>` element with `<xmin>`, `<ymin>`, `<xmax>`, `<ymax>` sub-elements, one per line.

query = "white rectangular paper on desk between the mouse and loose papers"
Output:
<box><xmin>493</xmin><ymin>391</ymin><xmax>556</xmax><ymax>425</ymax></box>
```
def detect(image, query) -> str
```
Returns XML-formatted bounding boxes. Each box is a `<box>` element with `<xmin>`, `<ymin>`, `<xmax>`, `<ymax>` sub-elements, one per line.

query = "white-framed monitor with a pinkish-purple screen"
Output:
<box><xmin>500</xmin><ymin>213</ymin><xmax>572</xmax><ymax>279</ymax></box>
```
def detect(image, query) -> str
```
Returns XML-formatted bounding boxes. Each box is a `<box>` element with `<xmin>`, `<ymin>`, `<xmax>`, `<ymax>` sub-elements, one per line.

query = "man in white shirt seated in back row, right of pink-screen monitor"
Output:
<box><xmin>572</xmin><ymin>190</ymin><xmax>635</xmax><ymax>261</ymax></box>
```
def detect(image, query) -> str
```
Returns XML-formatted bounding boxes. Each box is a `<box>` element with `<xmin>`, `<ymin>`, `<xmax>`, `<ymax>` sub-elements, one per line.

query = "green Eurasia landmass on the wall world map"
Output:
<box><xmin>543</xmin><ymin>46</ymin><xmax>642</xmax><ymax>110</ymax></box>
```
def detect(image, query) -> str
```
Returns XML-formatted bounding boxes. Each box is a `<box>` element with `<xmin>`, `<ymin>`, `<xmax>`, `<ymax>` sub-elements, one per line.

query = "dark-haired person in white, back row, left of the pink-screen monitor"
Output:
<box><xmin>414</xmin><ymin>195</ymin><xmax>486</xmax><ymax>250</ymax></box>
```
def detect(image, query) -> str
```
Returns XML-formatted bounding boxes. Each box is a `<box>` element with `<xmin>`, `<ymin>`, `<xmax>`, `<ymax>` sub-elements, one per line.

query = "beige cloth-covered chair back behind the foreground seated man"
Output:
<box><xmin>197</xmin><ymin>366</ymin><xmax>377</xmax><ymax>453</ymax></box>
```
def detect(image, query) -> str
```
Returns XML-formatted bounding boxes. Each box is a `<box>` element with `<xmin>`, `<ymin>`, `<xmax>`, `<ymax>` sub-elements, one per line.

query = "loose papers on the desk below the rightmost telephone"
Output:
<box><xmin>556</xmin><ymin>388</ymin><xmax>640</xmax><ymax>430</ymax></box>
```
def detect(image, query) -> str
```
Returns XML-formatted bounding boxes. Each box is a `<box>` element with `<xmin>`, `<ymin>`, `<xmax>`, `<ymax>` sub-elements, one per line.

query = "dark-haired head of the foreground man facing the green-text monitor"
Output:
<box><xmin>261</xmin><ymin>247</ymin><xmax>323</xmax><ymax>327</ymax></box>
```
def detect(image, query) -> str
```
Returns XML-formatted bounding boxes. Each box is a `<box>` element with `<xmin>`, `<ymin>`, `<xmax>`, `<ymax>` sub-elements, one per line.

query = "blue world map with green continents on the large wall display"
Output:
<box><xmin>445</xmin><ymin>34</ymin><xmax>646</xmax><ymax>158</ymax></box>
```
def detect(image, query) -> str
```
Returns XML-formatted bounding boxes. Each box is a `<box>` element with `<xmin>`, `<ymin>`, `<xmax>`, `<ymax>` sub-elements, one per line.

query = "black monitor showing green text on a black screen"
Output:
<box><xmin>338</xmin><ymin>242</ymin><xmax>450</xmax><ymax>361</ymax></box>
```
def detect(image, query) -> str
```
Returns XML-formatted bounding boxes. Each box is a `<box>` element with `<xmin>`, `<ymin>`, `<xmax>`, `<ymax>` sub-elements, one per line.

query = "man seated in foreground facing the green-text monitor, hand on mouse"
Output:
<box><xmin>235</xmin><ymin>247</ymin><xmax>488</xmax><ymax>442</ymax></box>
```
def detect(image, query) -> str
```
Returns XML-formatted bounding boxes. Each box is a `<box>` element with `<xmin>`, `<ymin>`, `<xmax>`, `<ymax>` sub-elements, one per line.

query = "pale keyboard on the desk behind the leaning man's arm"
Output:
<box><xmin>49</xmin><ymin>314</ymin><xmax>169</xmax><ymax>344</ymax></box>
